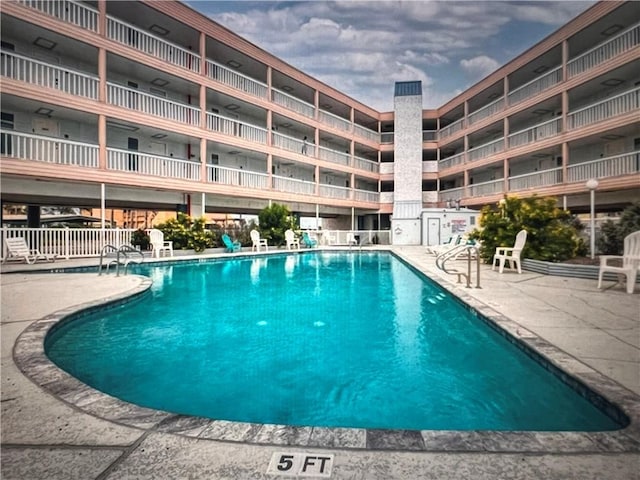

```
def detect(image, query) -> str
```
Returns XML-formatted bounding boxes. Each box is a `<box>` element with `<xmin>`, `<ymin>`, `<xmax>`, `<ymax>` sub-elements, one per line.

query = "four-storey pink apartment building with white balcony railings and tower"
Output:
<box><xmin>0</xmin><ymin>0</ymin><xmax>640</xmax><ymax>243</ymax></box>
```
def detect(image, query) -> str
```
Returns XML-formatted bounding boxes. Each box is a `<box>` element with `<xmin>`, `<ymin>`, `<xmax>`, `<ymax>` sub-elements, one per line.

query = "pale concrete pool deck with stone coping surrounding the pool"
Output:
<box><xmin>0</xmin><ymin>247</ymin><xmax>640</xmax><ymax>480</ymax></box>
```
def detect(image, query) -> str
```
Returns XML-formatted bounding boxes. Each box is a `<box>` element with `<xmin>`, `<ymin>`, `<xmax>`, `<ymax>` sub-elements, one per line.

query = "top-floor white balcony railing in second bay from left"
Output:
<box><xmin>107</xmin><ymin>16</ymin><xmax>200</xmax><ymax>72</ymax></box>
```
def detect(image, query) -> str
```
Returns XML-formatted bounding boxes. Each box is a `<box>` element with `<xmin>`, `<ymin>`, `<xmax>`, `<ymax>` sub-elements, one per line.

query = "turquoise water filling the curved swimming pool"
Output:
<box><xmin>45</xmin><ymin>252</ymin><xmax>620</xmax><ymax>431</ymax></box>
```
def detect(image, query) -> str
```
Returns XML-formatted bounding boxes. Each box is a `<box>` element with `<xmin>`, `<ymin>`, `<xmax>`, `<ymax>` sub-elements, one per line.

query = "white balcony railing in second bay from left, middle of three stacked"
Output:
<box><xmin>107</xmin><ymin>82</ymin><xmax>200</xmax><ymax>126</ymax></box>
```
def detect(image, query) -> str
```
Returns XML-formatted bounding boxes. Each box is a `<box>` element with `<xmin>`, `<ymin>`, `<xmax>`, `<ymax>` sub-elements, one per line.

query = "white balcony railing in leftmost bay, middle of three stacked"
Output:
<box><xmin>0</xmin><ymin>50</ymin><xmax>99</xmax><ymax>100</ymax></box>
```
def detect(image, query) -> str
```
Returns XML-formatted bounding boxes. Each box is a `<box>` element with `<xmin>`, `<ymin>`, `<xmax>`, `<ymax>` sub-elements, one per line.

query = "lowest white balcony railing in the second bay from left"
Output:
<box><xmin>107</xmin><ymin>148</ymin><xmax>200</xmax><ymax>181</ymax></box>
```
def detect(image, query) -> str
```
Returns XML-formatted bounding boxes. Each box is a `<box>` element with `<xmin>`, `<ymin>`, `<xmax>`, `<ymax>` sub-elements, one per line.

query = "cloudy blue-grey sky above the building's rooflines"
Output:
<box><xmin>186</xmin><ymin>0</ymin><xmax>595</xmax><ymax>112</ymax></box>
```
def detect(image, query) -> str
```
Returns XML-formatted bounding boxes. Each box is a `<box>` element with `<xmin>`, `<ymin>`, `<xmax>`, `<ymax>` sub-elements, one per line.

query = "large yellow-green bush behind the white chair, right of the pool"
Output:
<box><xmin>470</xmin><ymin>195</ymin><xmax>586</xmax><ymax>263</ymax></box>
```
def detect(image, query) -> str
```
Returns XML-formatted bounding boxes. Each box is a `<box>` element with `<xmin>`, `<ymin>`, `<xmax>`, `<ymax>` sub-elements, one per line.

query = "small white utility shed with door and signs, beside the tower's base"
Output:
<box><xmin>422</xmin><ymin>208</ymin><xmax>480</xmax><ymax>246</ymax></box>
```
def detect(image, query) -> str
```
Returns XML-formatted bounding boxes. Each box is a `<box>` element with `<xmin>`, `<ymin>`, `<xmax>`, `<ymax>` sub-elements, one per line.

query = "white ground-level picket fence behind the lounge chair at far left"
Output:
<box><xmin>0</xmin><ymin>228</ymin><xmax>135</xmax><ymax>258</ymax></box>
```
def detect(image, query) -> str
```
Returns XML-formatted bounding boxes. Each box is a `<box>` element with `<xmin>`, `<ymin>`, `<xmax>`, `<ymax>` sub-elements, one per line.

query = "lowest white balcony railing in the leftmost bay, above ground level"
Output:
<box><xmin>0</xmin><ymin>130</ymin><xmax>99</xmax><ymax>168</ymax></box>
